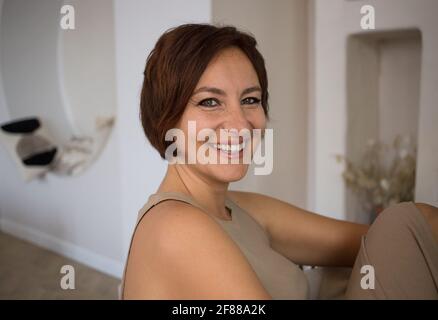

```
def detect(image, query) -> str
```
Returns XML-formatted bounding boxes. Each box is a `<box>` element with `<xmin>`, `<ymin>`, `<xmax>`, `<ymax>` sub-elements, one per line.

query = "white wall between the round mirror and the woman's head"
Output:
<box><xmin>0</xmin><ymin>0</ymin><xmax>210</xmax><ymax>277</ymax></box>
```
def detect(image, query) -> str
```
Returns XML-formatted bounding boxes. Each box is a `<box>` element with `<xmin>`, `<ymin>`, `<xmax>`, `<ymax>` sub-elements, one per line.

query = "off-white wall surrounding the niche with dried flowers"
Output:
<box><xmin>309</xmin><ymin>0</ymin><xmax>438</xmax><ymax>218</ymax></box>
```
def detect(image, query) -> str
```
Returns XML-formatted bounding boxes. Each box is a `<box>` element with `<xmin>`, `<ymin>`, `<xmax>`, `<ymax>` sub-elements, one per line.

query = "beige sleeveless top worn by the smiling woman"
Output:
<box><xmin>119</xmin><ymin>192</ymin><xmax>309</xmax><ymax>299</ymax></box>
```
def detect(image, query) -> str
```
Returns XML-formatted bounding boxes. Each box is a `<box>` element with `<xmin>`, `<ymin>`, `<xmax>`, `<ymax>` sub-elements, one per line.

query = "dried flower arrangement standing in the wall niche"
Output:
<box><xmin>336</xmin><ymin>135</ymin><xmax>416</xmax><ymax>215</ymax></box>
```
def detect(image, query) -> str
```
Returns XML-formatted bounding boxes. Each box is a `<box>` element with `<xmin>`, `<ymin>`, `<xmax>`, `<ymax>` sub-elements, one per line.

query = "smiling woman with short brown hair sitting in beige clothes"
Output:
<box><xmin>122</xmin><ymin>24</ymin><xmax>438</xmax><ymax>299</ymax></box>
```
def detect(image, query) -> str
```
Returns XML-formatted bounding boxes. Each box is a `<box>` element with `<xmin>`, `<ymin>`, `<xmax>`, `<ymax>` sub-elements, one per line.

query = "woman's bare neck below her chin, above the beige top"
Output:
<box><xmin>157</xmin><ymin>164</ymin><xmax>233</xmax><ymax>219</ymax></box>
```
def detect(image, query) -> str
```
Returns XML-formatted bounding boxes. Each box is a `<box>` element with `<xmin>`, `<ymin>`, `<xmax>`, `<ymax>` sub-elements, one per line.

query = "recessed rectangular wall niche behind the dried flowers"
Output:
<box><xmin>345</xmin><ymin>29</ymin><xmax>422</xmax><ymax>223</ymax></box>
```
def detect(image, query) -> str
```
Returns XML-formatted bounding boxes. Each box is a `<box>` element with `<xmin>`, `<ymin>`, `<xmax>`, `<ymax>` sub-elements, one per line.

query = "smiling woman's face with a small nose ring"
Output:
<box><xmin>178</xmin><ymin>48</ymin><xmax>266</xmax><ymax>183</ymax></box>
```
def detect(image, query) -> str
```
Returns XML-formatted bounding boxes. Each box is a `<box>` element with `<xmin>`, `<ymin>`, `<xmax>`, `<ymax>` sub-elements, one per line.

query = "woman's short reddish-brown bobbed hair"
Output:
<box><xmin>140</xmin><ymin>24</ymin><xmax>268</xmax><ymax>159</ymax></box>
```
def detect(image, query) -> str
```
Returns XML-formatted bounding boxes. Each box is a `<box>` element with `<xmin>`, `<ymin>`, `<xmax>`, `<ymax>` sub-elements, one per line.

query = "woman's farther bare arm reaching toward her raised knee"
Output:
<box><xmin>229</xmin><ymin>191</ymin><xmax>369</xmax><ymax>267</ymax></box>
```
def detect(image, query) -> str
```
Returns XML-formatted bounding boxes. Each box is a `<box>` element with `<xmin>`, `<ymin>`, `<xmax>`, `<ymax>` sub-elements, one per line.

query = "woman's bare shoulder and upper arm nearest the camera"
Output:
<box><xmin>124</xmin><ymin>200</ymin><xmax>269</xmax><ymax>299</ymax></box>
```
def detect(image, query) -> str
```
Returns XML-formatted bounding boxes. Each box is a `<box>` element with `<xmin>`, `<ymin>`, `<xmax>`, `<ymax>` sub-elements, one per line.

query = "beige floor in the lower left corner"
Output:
<box><xmin>0</xmin><ymin>232</ymin><xmax>120</xmax><ymax>299</ymax></box>
